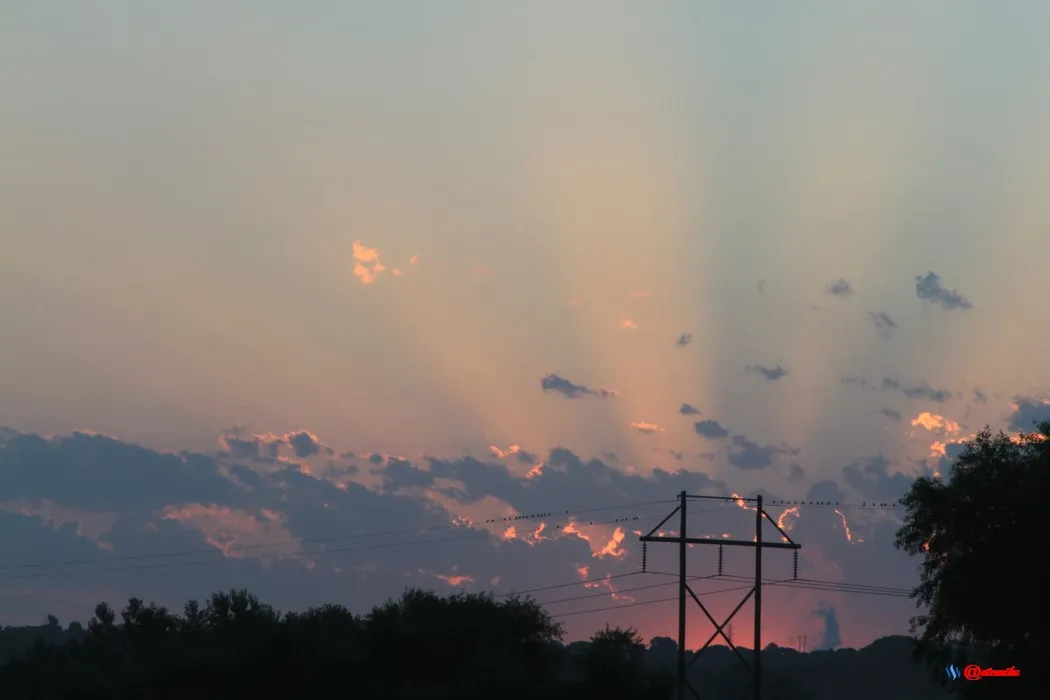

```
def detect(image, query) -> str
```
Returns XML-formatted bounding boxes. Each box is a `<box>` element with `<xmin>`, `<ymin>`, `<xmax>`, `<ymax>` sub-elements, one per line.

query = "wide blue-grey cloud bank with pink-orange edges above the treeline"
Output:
<box><xmin>0</xmin><ymin>429</ymin><xmax>936</xmax><ymax>641</ymax></box>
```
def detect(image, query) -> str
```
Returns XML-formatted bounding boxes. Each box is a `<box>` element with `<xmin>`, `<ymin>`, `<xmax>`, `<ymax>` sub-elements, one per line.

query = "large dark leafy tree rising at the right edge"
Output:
<box><xmin>896</xmin><ymin>422</ymin><xmax>1050</xmax><ymax>698</ymax></box>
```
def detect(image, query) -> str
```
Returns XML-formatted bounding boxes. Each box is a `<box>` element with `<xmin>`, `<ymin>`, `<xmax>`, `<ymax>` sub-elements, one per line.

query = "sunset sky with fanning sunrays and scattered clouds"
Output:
<box><xmin>0</xmin><ymin>0</ymin><xmax>1050</xmax><ymax>649</ymax></box>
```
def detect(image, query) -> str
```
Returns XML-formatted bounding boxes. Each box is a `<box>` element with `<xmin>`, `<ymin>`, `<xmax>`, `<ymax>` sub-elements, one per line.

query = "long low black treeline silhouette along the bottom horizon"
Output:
<box><xmin>0</xmin><ymin>590</ymin><xmax>945</xmax><ymax>700</ymax></box>
